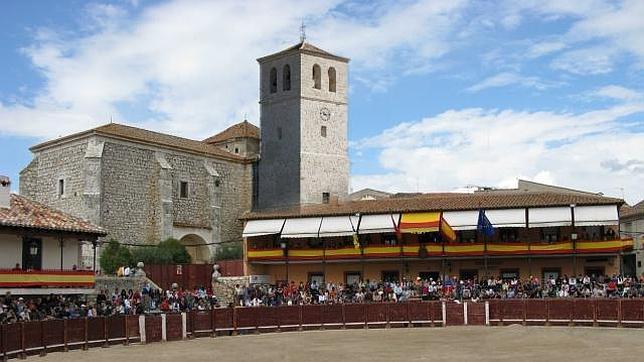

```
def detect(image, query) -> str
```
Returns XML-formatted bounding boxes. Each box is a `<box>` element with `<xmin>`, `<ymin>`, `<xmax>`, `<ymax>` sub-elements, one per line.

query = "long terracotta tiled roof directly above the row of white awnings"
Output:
<box><xmin>243</xmin><ymin>191</ymin><xmax>624</xmax><ymax>219</ymax></box>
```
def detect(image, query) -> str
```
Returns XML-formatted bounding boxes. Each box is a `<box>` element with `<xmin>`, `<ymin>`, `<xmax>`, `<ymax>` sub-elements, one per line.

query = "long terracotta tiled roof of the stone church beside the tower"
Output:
<box><xmin>31</xmin><ymin>123</ymin><xmax>247</xmax><ymax>162</ymax></box>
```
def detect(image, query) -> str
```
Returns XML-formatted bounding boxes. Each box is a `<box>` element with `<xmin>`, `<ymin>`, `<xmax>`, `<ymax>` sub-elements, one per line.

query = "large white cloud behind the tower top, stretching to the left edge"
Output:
<box><xmin>0</xmin><ymin>0</ymin><xmax>464</xmax><ymax>138</ymax></box>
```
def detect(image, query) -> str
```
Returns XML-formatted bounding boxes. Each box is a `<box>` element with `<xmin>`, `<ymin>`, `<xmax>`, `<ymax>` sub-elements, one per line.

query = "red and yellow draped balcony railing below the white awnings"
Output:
<box><xmin>247</xmin><ymin>239</ymin><xmax>633</xmax><ymax>262</ymax></box>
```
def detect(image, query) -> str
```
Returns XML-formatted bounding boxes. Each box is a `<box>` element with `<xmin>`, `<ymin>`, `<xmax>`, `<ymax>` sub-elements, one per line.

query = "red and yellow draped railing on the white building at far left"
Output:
<box><xmin>0</xmin><ymin>269</ymin><xmax>95</xmax><ymax>288</ymax></box>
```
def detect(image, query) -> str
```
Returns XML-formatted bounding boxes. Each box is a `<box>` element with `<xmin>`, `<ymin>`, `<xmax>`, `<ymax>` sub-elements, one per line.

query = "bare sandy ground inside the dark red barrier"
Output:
<box><xmin>36</xmin><ymin>326</ymin><xmax>644</xmax><ymax>362</ymax></box>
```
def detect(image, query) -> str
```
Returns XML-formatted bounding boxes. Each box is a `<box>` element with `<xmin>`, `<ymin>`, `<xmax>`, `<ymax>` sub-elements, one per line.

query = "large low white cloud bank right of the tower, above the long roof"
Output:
<box><xmin>352</xmin><ymin>103</ymin><xmax>644</xmax><ymax>202</ymax></box>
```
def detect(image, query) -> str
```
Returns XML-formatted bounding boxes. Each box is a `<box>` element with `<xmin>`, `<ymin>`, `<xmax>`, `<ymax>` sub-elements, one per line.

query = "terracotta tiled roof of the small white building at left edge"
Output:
<box><xmin>0</xmin><ymin>195</ymin><xmax>107</xmax><ymax>236</ymax></box>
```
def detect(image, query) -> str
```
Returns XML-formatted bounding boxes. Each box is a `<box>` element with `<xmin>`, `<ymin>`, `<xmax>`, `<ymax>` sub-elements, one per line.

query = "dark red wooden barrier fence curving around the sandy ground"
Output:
<box><xmin>0</xmin><ymin>299</ymin><xmax>644</xmax><ymax>360</ymax></box>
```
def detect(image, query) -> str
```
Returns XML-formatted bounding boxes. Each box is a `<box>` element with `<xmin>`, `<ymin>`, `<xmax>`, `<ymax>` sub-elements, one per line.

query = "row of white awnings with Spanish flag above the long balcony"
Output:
<box><xmin>243</xmin><ymin>205</ymin><xmax>619</xmax><ymax>238</ymax></box>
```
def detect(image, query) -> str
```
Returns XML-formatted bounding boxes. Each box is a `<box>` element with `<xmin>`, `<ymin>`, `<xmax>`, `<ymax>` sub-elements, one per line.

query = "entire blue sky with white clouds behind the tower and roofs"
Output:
<box><xmin>0</xmin><ymin>0</ymin><xmax>644</xmax><ymax>203</ymax></box>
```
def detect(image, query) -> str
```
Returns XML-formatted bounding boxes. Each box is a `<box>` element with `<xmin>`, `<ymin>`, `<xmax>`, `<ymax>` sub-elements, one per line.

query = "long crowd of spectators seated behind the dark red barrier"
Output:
<box><xmin>0</xmin><ymin>275</ymin><xmax>644</xmax><ymax>323</ymax></box>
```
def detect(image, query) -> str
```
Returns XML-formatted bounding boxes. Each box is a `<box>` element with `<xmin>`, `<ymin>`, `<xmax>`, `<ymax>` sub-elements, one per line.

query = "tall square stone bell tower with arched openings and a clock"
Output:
<box><xmin>256</xmin><ymin>41</ymin><xmax>349</xmax><ymax>209</ymax></box>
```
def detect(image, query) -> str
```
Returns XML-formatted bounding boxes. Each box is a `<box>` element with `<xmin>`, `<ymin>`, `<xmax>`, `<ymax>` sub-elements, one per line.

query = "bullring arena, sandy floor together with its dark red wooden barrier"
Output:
<box><xmin>0</xmin><ymin>299</ymin><xmax>644</xmax><ymax>362</ymax></box>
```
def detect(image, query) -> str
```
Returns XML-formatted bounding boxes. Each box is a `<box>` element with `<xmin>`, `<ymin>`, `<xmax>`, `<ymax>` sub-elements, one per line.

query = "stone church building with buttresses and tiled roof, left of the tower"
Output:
<box><xmin>20</xmin><ymin>122</ymin><xmax>259</xmax><ymax>264</ymax></box>
